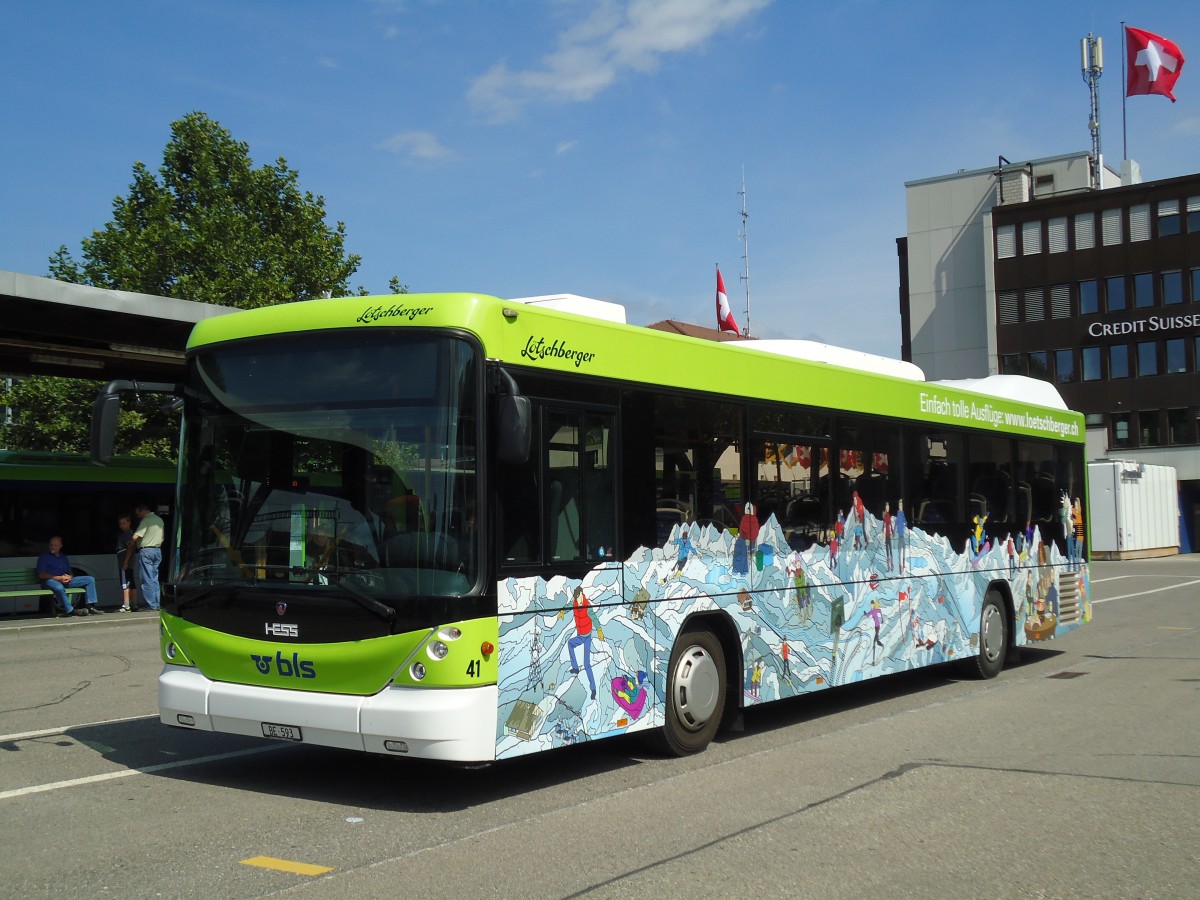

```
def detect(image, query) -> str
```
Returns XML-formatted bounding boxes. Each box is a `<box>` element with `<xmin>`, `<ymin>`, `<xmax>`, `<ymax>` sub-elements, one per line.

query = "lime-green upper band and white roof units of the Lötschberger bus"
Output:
<box><xmin>187</xmin><ymin>293</ymin><xmax>1084</xmax><ymax>443</ymax></box>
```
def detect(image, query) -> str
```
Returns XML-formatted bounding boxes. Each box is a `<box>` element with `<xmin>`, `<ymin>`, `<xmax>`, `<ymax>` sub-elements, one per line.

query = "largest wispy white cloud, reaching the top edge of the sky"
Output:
<box><xmin>467</xmin><ymin>0</ymin><xmax>770</xmax><ymax>122</ymax></box>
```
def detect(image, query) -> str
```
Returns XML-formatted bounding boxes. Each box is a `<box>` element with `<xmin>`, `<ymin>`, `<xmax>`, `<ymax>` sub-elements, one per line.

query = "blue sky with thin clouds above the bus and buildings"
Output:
<box><xmin>0</xmin><ymin>0</ymin><xmax>1200</xmax><ymax>356</ymax></box>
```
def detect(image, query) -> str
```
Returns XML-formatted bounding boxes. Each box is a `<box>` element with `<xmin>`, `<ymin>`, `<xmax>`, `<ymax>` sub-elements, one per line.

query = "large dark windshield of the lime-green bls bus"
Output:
<box><xmin>175</xmin><ymin>329</ymin><xmax>481</xmax><ymax>606</ymax></box>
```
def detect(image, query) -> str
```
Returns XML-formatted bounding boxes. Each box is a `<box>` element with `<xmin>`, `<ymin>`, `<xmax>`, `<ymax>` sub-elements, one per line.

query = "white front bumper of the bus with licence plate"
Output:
<box><xmin>158</xmin><ymin>665</ymin><xmax>498</xmax><ymax>762</ymax></box>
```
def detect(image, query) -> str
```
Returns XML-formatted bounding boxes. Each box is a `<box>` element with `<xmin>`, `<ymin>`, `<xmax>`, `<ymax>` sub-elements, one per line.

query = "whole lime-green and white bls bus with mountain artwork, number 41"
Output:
<box><xmin>97</xmin><ymin>294</ymin><xmax>1090</xmax><ymax>762</ymax></box>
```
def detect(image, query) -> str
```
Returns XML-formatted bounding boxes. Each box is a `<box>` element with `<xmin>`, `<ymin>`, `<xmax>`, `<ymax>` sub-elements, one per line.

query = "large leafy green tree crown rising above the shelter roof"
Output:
<box><xmin>50</xmin><ymin>113</ymin><xmax>361</xmax><ymax>308</ymax></box>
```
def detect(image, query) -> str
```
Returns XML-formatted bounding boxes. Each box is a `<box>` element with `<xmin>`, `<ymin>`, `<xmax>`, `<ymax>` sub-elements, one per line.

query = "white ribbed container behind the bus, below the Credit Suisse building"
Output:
<box><xmin>1087</xmin><ymin>460</ymin><xmax>1180</xmax><ymax>559</ymax></box>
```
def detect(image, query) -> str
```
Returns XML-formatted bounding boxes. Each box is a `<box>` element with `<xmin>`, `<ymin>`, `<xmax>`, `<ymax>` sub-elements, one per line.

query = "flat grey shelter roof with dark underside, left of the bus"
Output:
<box><xmin>0</xmin><ymin>270</ymin><xmax>234</xmax><ymax>382</ymax></box>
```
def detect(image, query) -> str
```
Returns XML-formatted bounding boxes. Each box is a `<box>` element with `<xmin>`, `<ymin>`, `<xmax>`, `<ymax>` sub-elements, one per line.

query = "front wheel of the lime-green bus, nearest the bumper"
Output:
<box><xmin>660</xmin><ymin>630</ymin><xmax>727</xmax><ymax>756</ymax></box>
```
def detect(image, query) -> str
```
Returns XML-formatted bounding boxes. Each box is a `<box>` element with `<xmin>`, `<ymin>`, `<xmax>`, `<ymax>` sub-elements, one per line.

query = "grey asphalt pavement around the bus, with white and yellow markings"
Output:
<box><xmin>0</xmin><ymin>556</ymin><xmax>1200</xmax><ymax>899</ymax></box>
